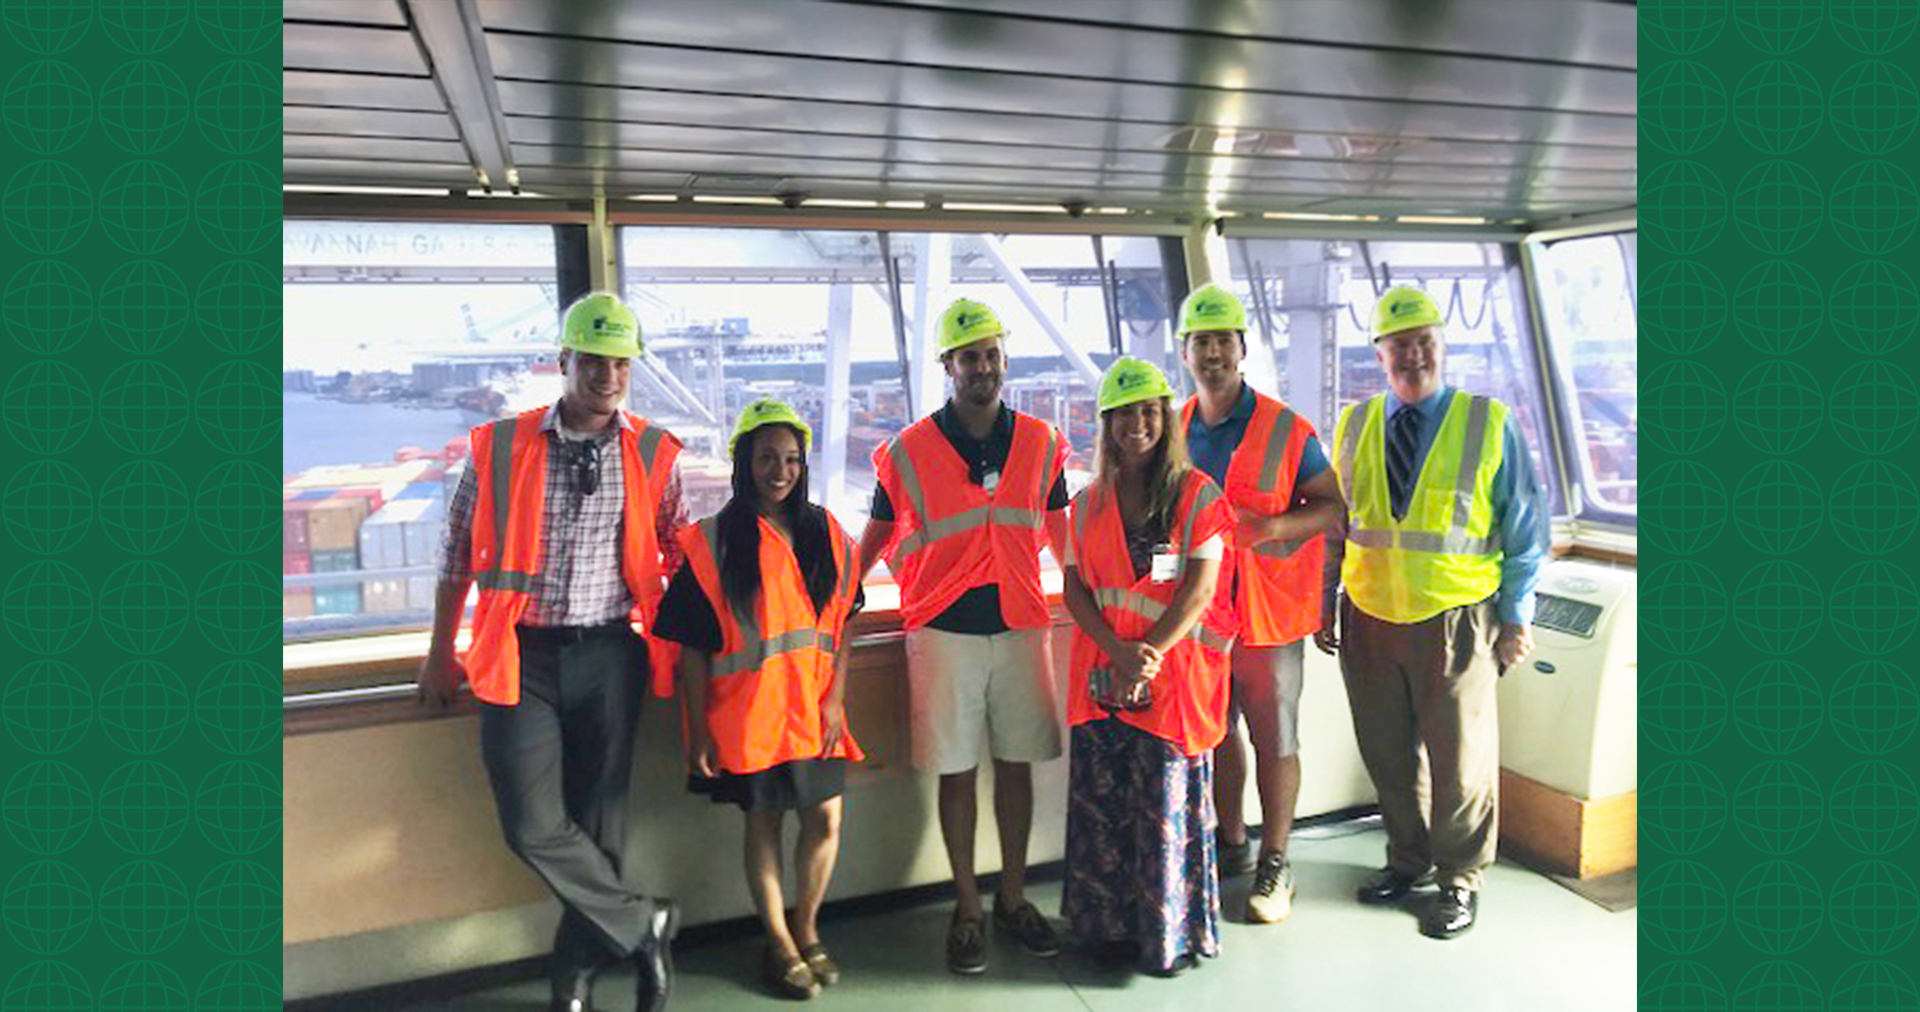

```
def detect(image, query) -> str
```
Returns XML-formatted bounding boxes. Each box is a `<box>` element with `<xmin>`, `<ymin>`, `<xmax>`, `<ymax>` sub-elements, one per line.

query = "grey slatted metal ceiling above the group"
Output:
<box><xmin>282</xmin><ymin>0</ymin><xmax>1638</xmax><ymax>219</ymax></box>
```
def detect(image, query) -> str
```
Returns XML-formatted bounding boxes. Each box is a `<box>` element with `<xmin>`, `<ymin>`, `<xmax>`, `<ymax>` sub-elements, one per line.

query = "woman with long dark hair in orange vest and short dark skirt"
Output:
<box><xmin>655</xmin><ymin>399</ymin><xmax>862</xmax><ymax>999</ymax></box>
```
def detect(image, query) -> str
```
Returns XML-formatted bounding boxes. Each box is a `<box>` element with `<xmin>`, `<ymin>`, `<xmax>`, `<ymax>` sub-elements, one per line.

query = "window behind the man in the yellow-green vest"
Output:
<box><xmin>1227</xmin><ymin>238</ymin><xmax>1567</xmax><ymax>515</ymax></box>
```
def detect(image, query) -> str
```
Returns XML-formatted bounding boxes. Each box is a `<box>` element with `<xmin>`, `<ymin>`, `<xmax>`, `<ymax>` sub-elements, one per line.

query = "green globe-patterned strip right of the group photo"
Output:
<box><xmin>1640</xmin><ymin>0</ymin><xmax>1920</xmax><ymax>1012</ymax></box>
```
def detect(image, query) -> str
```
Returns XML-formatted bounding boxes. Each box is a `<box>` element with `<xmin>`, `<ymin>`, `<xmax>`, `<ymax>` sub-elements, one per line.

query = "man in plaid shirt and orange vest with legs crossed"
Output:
<box><xmin>420</xmin><ymin>294</ymin><xmax>687</xmax><ymax>1012</ymax></box>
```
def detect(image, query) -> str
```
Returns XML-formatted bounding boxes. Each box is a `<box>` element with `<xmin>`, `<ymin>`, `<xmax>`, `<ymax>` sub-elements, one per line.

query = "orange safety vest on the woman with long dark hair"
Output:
<box><xmin>680</xmin><ymin>513</ymin><xmax>866</xmax><ymax>774</ymax></box>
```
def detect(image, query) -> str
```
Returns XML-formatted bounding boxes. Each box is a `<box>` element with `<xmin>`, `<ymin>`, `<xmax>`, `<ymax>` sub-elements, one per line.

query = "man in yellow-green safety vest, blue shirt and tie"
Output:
<box><xmin>1315</xmin><ymin>288</ymin><xmax>1548</xmax><ymax>939</ymax></box>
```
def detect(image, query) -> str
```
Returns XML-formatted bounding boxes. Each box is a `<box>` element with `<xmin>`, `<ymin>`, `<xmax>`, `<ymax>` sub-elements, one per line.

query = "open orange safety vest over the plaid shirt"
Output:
<box><xmin>467</xmin><ymin>407</ymin><xmax>680</xmax><ymax>707</ymax></box>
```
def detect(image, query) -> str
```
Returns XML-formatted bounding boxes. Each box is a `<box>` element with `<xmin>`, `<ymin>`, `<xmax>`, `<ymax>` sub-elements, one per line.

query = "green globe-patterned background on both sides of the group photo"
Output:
<box><xmin>0</xmin><ymin>0</ymin><xmax>1920</xmax><ymax>1012</ymax></box>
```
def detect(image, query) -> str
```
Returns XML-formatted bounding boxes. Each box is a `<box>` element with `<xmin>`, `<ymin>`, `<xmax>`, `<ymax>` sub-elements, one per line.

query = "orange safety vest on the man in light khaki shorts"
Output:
<box><xmin>874</xmin><ymin>411</ymin><xmax>1068</xmax><ymax>630</ymax></box>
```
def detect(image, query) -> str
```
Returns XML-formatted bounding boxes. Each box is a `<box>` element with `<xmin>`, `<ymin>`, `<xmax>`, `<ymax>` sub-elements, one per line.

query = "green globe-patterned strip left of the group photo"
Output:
<box><xmin>0</xmin><ymin>0</ymin><xmax>280</xmax><ymax>1012</ymax></box>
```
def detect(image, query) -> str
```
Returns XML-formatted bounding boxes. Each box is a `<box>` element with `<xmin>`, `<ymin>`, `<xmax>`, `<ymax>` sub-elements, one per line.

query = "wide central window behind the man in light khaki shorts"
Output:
<box><xmin>618</xmin><ymin>225</ymin><xmax>1179</xmax><ymax>611</ymax></box>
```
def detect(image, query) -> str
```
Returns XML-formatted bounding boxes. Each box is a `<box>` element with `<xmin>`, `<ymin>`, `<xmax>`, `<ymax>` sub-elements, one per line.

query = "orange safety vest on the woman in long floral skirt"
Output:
<box><xmin>1068</xmin><ymin>469</ymin><xmax>1236</xmax><ymax>757</ymax></box>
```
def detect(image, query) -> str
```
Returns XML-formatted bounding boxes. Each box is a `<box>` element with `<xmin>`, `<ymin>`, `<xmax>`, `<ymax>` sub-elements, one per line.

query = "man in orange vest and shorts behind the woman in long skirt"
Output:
<box><xmin>1179</xmin><ymin>284</ymin><xmax>1346</xmax><ymax>924</ymax></box>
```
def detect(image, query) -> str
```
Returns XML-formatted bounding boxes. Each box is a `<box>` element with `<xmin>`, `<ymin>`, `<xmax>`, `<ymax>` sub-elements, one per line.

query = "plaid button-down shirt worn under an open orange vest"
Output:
<box><xmin>440</xmin><ymin>405</ymin><xmax>687</xmax><ymax>626</ymax></box>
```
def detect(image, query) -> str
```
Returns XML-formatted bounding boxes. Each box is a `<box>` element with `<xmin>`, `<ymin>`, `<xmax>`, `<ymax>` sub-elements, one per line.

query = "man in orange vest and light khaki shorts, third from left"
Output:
<box><xmin>860</xmin><ymin>300</ymin><xmax>1068</xmax><ymax>974</ymax></box>
